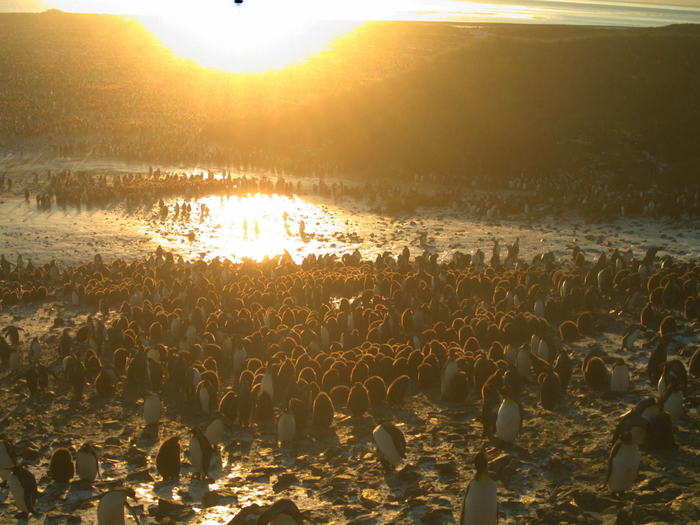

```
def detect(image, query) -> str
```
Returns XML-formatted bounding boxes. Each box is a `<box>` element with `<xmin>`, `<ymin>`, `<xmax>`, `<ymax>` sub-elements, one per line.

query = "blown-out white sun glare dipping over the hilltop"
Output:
<box><xmin>46</xmin><ymin>0</ymin><xmax>537</xmax><ymax>73</ymax></box>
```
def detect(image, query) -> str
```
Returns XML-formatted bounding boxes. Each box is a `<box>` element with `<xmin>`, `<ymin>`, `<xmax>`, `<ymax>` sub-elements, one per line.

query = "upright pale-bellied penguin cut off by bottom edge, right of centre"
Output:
<box><xmin>459</xmin><ymin>449</ymin><xmax>498</xmax><ymax>525</ymax></box>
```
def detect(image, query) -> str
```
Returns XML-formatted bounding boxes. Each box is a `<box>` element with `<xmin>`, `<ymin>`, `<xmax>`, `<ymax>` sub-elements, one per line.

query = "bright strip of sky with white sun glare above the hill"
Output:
<box><xmin>0</xmin><ymin>0</ymin><xmax>700</xmax><ymax>72</ymax></box>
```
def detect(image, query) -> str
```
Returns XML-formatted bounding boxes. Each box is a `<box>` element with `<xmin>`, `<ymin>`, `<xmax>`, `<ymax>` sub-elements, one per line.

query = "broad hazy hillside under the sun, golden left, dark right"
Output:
<box><xmin>0</xmin><ymin>13</ymin><xmax>700</xmax><ymax>182</ymax></box>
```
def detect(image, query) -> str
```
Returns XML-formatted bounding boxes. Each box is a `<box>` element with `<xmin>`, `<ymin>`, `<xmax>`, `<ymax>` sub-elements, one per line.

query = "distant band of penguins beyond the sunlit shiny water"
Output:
<box><xmin>5</xmin><ymin>163</ymin><xmax>700</xmax><ymax>221</ymax></box>
